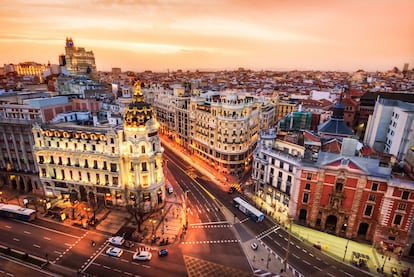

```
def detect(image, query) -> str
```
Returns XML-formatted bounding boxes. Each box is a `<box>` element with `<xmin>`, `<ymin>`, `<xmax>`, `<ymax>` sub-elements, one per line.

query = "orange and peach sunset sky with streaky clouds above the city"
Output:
<box><xmin>0</xmin><ymin>0</ymin><xmax>414</xmax><ymax>71</ymax></box>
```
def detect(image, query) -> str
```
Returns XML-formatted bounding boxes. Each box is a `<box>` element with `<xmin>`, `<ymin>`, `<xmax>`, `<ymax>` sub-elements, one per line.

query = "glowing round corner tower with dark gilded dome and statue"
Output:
<box><xmin>120</xmin><ymin>81</ymin><xmax>165</xmax><ymax>208</ymax></box>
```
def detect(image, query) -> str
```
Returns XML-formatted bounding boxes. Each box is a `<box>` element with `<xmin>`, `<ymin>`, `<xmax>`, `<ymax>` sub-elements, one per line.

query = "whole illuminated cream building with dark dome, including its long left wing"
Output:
<box><xmin>33</xmin><ymin>82</ymin><xmax>165</xmax><ymax>210</ymax></box>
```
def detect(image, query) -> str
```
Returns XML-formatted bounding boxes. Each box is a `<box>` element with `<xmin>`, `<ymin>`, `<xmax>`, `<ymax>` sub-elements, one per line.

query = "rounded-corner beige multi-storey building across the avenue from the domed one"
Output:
<box><xmin>189</xmin><ymin>91</ymin><xmax>261</xmax><ymax>175</ymax></box>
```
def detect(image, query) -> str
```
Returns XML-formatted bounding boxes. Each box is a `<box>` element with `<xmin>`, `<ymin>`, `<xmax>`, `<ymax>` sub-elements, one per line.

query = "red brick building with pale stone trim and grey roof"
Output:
<box><xmin>296</xmin><ymin>148</ymin><xmax>414</xmax><ymax>251</ymax></box>
